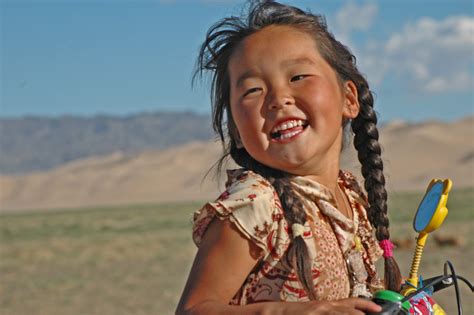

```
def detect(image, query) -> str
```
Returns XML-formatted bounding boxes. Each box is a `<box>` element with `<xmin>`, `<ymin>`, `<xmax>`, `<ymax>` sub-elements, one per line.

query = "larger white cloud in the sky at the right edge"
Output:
<box><xmin>361</xmin><ymin>16</ymin><xmax>474</xmax><ymax>92</ymax></box>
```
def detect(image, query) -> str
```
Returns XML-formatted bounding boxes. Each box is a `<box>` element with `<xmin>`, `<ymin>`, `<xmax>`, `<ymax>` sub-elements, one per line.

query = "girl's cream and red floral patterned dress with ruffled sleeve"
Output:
<box><xmin>193</xmin><ymin>169</ymin><xmax>382</xmax><ymax>305</ymax></box>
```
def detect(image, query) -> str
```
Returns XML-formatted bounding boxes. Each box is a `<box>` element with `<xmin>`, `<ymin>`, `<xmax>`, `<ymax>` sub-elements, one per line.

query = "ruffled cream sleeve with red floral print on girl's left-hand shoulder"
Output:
<box><xmin>193</xmin><ymin>169</ymin><xmax>283</xmax><ymax>256</ymax></box>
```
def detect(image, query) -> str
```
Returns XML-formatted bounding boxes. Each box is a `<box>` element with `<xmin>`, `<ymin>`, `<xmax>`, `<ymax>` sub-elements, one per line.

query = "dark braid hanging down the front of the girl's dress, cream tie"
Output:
<box><xmin>230</xmin><ymin>146</ymin><xmax>316</xmax><ymax>300</ymax></box>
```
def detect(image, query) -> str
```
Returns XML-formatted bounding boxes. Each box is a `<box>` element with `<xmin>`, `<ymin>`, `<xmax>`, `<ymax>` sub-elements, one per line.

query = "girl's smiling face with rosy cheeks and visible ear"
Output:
<box><xmin>228</xmin><ymin>26</ymin><xmax>359</xmax><ymax>175</ymax></box>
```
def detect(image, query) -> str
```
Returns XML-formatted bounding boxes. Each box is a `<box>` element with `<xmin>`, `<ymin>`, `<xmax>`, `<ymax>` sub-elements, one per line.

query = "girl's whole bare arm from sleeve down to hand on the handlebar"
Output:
<box><xmin>176</xmin><ymin>219</ymin><xmax>380</xmax><ymax>315</ymax></box>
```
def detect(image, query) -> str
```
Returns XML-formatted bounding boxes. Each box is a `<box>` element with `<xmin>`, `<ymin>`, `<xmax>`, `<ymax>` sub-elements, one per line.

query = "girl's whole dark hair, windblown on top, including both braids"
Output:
<box><xmin>194</xmin><ymin>0</ymin><xmax>401</xmax><ymax>299</ymax></box>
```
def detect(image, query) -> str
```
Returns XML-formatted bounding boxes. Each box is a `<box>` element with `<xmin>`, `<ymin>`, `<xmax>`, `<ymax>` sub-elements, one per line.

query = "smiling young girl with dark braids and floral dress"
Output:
<box><xmin>176</xmin><ymin>1</ymin><xmax>401</xmax><ymax>314</ymax></box>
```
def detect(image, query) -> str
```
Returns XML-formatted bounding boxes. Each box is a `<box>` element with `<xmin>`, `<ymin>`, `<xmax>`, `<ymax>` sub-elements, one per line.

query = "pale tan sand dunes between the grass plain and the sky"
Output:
<box><xmin>0</xmin><ymin>117</ymin><xmax>474</xmax><ymax>210</ymax></box>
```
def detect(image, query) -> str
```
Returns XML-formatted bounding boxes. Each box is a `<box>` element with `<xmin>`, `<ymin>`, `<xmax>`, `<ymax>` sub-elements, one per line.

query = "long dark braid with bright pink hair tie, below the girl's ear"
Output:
<box><xmin>352</xmin><ymin>84</ymin><xmax>402</xmax><ymax>291</ymax></box>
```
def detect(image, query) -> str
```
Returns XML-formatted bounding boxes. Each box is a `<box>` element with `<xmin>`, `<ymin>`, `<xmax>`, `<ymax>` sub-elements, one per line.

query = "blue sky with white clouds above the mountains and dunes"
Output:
<box><xmin>0</xmin><ymin>0</ymin><xmax>474</xmax><ymax>121</ymax></box>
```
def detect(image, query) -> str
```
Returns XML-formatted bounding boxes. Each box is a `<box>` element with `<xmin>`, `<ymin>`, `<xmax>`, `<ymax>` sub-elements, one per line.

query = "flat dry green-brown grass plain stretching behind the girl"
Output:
<box><xmin>0</xmin><ymin>189</ymin><xmax>474</xmax><ymax>315</ymax></box>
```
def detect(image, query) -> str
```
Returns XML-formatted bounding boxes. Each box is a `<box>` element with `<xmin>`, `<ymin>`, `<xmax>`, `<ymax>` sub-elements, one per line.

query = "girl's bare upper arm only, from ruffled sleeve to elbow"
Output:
<box><xmin>176</xmin><ymin>219</ymin><xmax>261</xmax><ymax>314</ymax></box>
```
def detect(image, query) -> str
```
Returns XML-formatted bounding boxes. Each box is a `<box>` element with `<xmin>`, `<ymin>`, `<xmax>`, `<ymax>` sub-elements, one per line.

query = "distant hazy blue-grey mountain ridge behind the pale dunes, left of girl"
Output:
<box><xmin>0</xmin><ymin>112</ymin><xmax>213</xmax><ymax>175</ymax></box>
